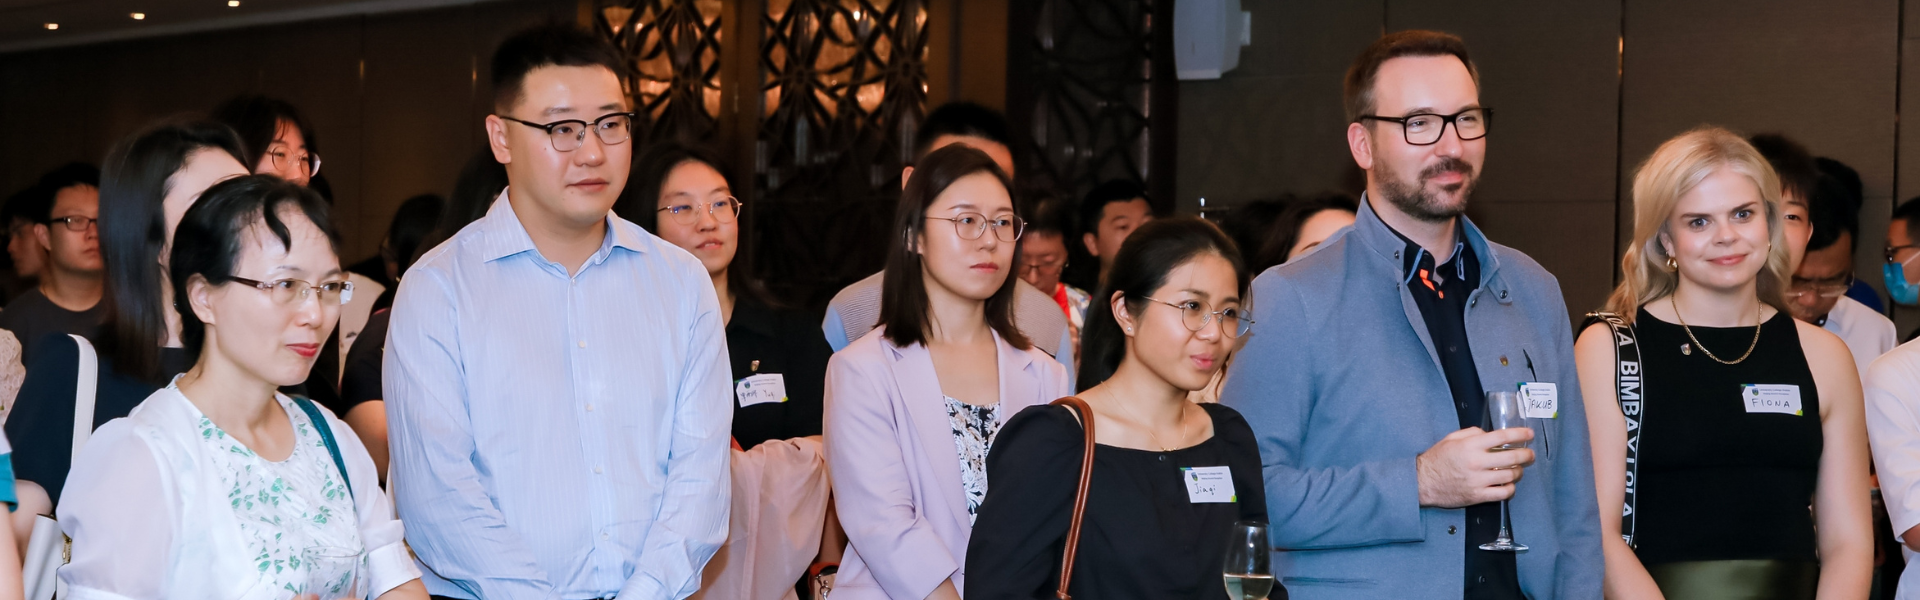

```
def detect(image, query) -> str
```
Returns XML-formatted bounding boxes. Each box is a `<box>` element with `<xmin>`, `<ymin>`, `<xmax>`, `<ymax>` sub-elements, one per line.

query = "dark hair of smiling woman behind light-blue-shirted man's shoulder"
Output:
<box><xmin>612</xmin><ymin>140</ymin><xmax>781</xmax><ymax>306</ymax></box>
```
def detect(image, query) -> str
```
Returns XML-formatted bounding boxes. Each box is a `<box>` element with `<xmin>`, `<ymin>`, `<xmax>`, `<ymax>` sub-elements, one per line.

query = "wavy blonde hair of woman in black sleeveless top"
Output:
<box><xmin>1605</xmin><ymin>127</ymin><xmax>1789</xmax><ymax>321</ymax></box>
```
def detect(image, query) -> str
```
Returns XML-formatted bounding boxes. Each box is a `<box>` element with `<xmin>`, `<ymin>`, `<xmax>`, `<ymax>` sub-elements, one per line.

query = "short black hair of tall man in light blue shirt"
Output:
<box><xmin>492</xmin><ymin>23</ymin><xmax>626</xmax><ymax>113</ymax></box>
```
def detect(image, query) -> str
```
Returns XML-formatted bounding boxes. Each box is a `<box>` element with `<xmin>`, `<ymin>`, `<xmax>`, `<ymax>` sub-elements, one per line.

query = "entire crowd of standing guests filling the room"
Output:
<box><xmin>0</xmin><ymin>18</ymin><xmax>1920</xmax><ymax>600</ymax></box>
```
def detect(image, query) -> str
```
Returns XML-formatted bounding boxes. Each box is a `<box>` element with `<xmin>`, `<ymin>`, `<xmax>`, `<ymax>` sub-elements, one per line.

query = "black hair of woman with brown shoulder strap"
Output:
<box><xmin>1073</xmin><ymin>217</ymin><xmax>1252</xmax><ymax>392</ymax></box>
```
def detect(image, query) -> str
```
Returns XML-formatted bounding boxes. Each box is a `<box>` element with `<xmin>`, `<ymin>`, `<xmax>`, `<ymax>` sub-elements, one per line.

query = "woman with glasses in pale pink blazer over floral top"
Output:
<box><xmin>826</xmin><ymin>144</ymin><xmax>1071</xmax><ymax>600</ymax></box>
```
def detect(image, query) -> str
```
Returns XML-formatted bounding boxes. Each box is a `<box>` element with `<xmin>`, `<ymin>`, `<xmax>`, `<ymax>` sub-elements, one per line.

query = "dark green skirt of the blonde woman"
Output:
<box><xmin>1647</xmin><ymin>560</ymin><xmax>1820</xmax><ymax>600</ymax></box>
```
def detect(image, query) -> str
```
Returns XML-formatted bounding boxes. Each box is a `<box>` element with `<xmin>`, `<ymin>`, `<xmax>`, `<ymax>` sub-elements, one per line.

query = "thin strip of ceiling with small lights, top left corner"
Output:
<box><xmin>0</xmin><ymin>0</ymin><xmax>488</xmax><ymax>52</ymax></box>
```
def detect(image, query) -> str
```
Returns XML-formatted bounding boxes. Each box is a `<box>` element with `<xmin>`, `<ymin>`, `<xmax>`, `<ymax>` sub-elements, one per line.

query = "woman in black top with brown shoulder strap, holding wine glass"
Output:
<box><xmin>966</xmin><ymin>217</ymin><xmax>1286</xmax><ymax>600</ymax></box>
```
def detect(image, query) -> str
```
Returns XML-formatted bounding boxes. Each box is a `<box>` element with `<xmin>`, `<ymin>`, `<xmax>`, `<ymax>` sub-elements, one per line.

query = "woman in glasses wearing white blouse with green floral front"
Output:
<box><xmin>60</xmin><ymin>175</ymin><xmax>426</xmax><ymax>600</ymax></box>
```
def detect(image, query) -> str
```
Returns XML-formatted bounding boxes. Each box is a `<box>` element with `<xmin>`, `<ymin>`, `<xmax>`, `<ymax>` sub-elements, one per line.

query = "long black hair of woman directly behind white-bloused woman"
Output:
<box><xmin>100</xmin><ymin>119</ymin><xmax>246</xmax><ymax>383</ymax></box>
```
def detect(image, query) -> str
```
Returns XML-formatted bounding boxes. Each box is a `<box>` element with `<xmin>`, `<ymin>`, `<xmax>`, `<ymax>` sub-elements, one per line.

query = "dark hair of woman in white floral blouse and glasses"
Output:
<box><xmin>167</xmin><ymin>175</ymin><xmax>340</xmax><ymax>356</ymax></box>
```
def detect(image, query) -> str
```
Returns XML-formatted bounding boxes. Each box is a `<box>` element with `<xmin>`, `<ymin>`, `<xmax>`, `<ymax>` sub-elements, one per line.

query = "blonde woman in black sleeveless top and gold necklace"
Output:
<box><xmin>1574</xmin><ymin>127</ymin><xmax>1874</xmax><ymax>598</ymax></box>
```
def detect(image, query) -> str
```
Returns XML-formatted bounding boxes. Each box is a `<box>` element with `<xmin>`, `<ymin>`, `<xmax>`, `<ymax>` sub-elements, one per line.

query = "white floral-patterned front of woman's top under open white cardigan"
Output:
<box><xmin>182</xmin><ymin>382</ymin><xmax>361</xmax><ymax>598</ymax></box>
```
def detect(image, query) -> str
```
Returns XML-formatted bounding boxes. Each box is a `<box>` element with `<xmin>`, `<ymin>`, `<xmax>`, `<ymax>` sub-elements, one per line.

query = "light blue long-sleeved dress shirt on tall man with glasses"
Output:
<box><xmin>384</xmin><ymin>194</ymin><xmax>733</xmax><ymax>600</ymax></box>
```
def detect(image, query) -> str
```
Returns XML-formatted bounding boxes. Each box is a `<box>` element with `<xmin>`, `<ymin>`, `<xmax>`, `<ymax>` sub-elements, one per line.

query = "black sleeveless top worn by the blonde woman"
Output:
<box><xmin>1634</xmin><ymin>308</ymin><xmax>1822</xmax><ymax>565</ymax></box>
